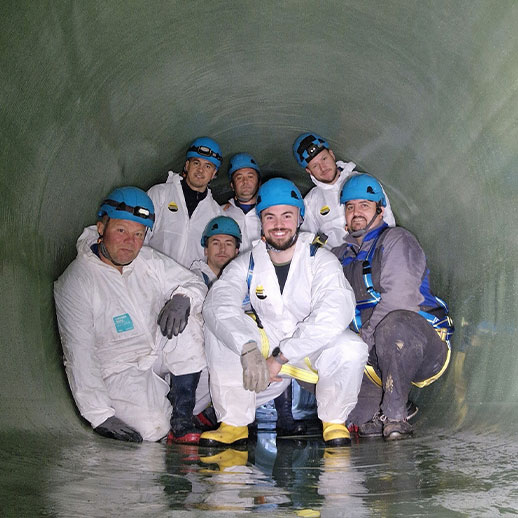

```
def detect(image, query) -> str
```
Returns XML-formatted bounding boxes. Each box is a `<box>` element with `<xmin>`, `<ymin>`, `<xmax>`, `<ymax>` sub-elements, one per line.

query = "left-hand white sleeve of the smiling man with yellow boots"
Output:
<box><xmin>203</xmin><ymin>253</ymin><xmax>256</xmax><ymax>354</ymax></box>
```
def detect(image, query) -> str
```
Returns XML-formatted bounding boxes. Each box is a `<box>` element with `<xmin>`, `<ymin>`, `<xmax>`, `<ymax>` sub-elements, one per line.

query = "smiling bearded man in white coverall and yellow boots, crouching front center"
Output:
<box><xmin>200</xmin><ymin>178</ymin><xmax>367</xmax><ymax>446</ymax></box>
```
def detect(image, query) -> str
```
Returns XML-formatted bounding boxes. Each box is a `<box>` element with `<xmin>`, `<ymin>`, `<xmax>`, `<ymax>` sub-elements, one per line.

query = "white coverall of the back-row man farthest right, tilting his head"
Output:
<box><xmin>302</xmin><ymin>161</ymin><xmax>396</xmax><ymax>249</ymax></box>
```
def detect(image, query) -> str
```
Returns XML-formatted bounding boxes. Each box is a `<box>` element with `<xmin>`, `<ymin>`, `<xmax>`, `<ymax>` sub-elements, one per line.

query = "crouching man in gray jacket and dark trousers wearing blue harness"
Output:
<box><xmin>333</xmin><ymin>174</ymin><xmax>453</xmax><ymax>440</ymax></box>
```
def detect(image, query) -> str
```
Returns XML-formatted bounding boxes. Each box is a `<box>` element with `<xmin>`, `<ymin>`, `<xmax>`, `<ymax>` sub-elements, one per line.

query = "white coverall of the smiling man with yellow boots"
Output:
<box><xmin>203</xmin><ymin>233</ymin><xmax>367</xmax><ymax>426</ymax></box>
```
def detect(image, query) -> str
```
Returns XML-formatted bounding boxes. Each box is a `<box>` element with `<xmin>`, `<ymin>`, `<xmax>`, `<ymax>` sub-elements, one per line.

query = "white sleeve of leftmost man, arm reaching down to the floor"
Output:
<box><xmin>54</xmin><ymin>271</ymin><xmax>115</xmax><ymax>428</ymax></box>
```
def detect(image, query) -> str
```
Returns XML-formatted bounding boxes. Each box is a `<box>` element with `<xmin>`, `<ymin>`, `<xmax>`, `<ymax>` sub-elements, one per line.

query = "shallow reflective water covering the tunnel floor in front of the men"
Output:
<box><xmin>0</xmin><ymin>433</ymin><xmax>518</xmax><ymax>517</ymax></box>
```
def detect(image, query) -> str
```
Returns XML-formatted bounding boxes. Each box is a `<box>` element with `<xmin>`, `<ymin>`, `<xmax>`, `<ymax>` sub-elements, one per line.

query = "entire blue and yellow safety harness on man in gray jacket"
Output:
<box><xmin>342</xmin><ymin>228</ymin><xmax>455</xmax><ymax>388</ymax></box>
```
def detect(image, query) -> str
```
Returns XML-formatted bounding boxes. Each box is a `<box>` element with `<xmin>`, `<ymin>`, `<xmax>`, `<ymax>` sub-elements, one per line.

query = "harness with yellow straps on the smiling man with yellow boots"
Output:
<box><xmin>243</xmin><ymin>233</ymin><xmax>327</xmax><ymax>383</ymax></box>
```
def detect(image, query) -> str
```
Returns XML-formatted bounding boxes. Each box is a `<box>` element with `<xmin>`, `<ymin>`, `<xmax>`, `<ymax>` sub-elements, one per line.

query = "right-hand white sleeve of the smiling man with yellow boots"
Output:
<box><xmin>279</xmin><ymin>249</ymin><xmax>356</xmax><ymax>362</ymax></box>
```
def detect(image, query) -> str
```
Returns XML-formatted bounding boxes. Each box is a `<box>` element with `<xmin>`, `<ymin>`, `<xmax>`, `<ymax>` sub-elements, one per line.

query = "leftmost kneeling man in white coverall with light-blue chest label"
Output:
<box><xmin>54</xmin><ymin>187</ymin><xmax>208</xmax><ymax>442</ymax></box>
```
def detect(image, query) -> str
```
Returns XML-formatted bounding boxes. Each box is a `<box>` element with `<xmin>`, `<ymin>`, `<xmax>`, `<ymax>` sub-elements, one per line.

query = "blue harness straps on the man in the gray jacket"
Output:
<box><xmin>348</xmin><ymin>232</ymin><xmax>455</xmax><ymax>348</ymax></box>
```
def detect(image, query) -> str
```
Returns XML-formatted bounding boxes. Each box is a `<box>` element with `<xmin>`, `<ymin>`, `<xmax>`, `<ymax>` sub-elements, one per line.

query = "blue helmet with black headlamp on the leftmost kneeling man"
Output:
<box><xmin>97</xmin><ymin>187</ymin><xmax>155</xmax><ymax>228</ymax></box>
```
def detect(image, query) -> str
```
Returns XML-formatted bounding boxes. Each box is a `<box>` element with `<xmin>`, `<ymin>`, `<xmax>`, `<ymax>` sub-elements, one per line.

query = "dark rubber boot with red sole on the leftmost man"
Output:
<box><xmin>167</xmin><ymin>372</ymin><xmax>201</xmax><ymax>444</ymax></box>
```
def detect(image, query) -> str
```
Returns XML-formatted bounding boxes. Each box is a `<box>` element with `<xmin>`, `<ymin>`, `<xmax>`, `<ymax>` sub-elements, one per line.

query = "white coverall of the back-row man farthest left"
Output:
<box><xmin>145</xmin><ymin>171</ymin><xmax>221</xmax><ymax>268</ymax></box>
